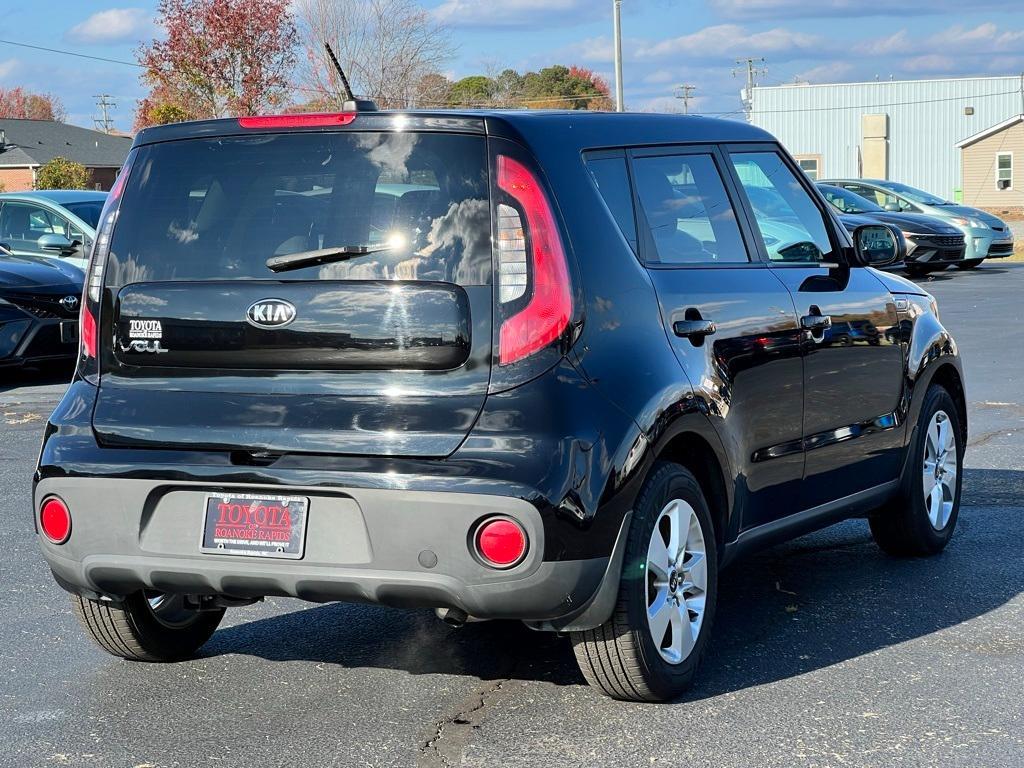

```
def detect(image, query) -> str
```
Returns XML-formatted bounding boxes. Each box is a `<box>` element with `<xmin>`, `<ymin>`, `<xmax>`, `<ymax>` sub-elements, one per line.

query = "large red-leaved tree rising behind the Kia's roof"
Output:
<box><xmin>135</xmin><ymin>0</ymin><xmax>298</xmax><ymax>130</ymax></box>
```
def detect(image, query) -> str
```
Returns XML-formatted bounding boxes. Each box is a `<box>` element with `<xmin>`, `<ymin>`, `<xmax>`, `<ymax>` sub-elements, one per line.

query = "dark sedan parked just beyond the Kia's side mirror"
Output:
<box><xmin>818</xmin><ymin>182</ymin><xmax>967</xmax><ymax>275</ymax></box>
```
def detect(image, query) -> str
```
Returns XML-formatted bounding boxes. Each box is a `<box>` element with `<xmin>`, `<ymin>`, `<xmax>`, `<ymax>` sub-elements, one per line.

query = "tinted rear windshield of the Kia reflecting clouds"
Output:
<box><xmin>106</xmin><ymin>132</ymin><xmax>490</xmax><ymax>286</ymax></box>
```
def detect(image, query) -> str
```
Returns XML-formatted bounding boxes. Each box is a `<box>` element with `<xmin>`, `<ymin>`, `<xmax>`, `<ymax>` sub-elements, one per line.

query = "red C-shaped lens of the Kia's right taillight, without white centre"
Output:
<box><xmin>498</xmin><ymin>155</ymin><xmax>572</xmax><ymax>366</ymax></box>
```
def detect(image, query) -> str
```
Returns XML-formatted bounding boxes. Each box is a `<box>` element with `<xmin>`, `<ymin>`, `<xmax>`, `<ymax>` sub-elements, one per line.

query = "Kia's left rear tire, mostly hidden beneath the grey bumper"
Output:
<box><xmin>72</xmin><ymin>592</ymin><xmax>224</xmax><ymax>662</ymax></box>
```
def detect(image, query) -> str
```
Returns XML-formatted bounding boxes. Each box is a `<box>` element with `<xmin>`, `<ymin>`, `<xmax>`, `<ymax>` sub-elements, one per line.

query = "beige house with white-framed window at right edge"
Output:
<box><xmin>956</xmin><ymin>115</ymin><xmax>1024</xmax><ymax>213</ymax></box>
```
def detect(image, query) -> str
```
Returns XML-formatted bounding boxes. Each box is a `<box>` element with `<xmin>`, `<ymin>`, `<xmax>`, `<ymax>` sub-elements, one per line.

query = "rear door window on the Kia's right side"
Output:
<box><xmin>633</xmin><ymin>155</ymin><xmax>750</xmax><ymax>264</ymax></box>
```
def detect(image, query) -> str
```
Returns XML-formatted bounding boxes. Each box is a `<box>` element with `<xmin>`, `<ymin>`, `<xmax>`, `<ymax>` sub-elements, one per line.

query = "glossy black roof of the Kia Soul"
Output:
<box><xmin>135</xmin><ymin>110</ymin><xmax>775</xmax><ymax>150</ymax></box>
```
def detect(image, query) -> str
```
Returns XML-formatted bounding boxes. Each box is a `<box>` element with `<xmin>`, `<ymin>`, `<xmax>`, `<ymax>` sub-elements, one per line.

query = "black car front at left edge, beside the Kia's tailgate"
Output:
<box><xmin>0</xmin><ymin>246</ymin><xmax>85</xmax><ymax>368</ymax></box>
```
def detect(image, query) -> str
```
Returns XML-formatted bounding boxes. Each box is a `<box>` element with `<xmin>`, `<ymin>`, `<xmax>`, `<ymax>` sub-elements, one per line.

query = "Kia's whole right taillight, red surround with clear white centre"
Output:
<box><xmin>498</xmin><ymin>155</ymin><xmax>572</xmax><ymax>366</ymax></box>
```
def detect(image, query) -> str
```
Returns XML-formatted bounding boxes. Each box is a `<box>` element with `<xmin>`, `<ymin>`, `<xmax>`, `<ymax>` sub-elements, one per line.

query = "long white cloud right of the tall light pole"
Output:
<box><xmin>637</xmin><ymin>24</ymin><xmax>822</xmax><ymax>58</ymax></box>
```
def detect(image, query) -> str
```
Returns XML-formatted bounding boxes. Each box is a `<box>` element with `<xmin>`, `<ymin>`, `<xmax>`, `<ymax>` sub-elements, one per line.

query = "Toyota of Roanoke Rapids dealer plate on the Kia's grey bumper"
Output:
<box><xmin>200</xmin><ymin>494</ymin><xmax>309</xmax><ymax>560</ymax></box>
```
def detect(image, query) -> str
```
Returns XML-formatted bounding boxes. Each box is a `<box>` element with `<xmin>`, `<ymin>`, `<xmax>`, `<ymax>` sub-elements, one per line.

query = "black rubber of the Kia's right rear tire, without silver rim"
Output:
<box><xmin>571</xmin><ymin>462</ymin><xmax>718</xmax><ymax>701</ymax></box>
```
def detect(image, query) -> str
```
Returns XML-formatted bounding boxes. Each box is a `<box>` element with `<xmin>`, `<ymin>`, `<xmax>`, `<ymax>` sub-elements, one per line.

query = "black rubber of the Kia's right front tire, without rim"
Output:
<box><xmin>869</xmin><ymin>384</ymin><xmax>964</xmax><ymax>557</ymax></box>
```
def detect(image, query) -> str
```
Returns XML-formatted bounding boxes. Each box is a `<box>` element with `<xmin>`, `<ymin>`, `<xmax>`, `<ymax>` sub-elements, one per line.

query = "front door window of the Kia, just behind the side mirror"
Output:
<box><xmin>731</xmin><ymin>152</ymin><xmax>833</xmax><ymax>262</ymax></box>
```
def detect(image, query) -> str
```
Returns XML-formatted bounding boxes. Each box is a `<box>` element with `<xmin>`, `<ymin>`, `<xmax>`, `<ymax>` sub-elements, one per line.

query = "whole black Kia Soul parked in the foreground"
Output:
<box><xmin>35</xmin><ymin>112</ymin><xmax>967</xmax><ymax>700</ymax></box>
